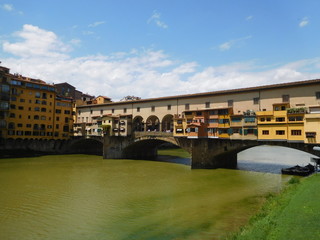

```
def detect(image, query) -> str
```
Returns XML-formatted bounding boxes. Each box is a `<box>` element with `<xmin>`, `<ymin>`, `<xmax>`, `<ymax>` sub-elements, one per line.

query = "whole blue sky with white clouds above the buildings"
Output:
<box><xmin>0</xmin><ymin>0</ymin><xmax>320</xmax><ymax>101</ymax></box>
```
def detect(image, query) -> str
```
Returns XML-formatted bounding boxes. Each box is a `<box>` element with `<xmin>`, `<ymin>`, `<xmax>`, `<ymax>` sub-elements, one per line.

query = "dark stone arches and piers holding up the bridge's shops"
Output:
<box><xmin>103</xmin><ymin>132</ymin><xmax>318</xmax><ymax>169</ymax></box>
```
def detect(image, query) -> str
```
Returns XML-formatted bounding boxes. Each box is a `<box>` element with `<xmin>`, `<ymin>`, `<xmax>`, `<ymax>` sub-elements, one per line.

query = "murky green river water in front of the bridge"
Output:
<box><xmin>0</xmin><ymin>155</ymin><xmax>288</xmax><ymax>240</ymax></box>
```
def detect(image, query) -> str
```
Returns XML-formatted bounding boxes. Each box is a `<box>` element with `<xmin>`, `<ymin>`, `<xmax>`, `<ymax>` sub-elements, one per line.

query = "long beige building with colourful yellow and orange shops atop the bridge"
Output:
<box><xmin>76</xmin><ymin>79</ymin><xmax>320</xmax><ymax>143</ymax></box>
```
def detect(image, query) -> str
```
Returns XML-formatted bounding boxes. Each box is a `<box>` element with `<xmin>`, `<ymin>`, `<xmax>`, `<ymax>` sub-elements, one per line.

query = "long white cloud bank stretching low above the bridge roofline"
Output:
<box><xmin>1</xmin><ymin>25</ymin><xmax>320</xmax><ymax>100</ymax></box>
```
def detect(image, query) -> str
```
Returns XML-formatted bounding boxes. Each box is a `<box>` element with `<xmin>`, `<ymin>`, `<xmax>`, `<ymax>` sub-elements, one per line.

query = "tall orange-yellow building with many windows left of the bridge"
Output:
<box><xmin>5</xmin><ymin>66</ymin><xmax>73</xmax><ymax>139</ymax></box>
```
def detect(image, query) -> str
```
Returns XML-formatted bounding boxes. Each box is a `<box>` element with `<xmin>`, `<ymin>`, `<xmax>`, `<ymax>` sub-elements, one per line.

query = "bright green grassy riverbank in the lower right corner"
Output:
<box><xmin>227</xmin><ymin>174</ymin><xmax>320</xmax><ymax>240</ymax></box>
